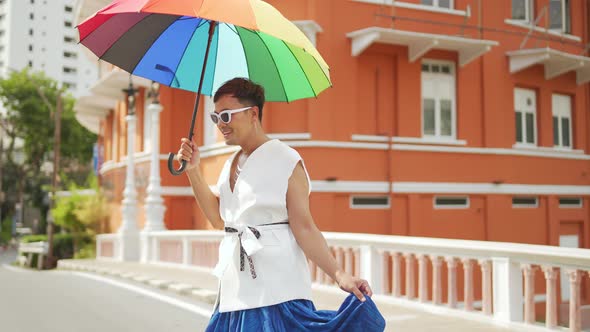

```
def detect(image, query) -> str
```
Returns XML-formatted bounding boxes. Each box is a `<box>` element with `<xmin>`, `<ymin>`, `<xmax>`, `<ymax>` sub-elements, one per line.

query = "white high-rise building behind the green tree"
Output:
<box><xmin>0</xmin><ymin>0</ymin><xmax>98</xmax><ymax>97</ymax></box>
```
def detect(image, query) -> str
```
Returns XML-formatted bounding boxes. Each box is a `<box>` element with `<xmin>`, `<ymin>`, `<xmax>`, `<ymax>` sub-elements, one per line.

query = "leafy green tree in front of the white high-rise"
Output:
<box><xmin>0</xmin><ymin>69</ymin><xmax>96</xmax><ymax>232</ymax></box>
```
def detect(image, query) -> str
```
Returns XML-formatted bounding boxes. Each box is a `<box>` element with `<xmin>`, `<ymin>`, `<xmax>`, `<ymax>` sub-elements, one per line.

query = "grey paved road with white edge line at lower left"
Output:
<box><xmin>0</xmin><ymin>249</ymin><xmax>212</xmax><ymax>332</ymax></box>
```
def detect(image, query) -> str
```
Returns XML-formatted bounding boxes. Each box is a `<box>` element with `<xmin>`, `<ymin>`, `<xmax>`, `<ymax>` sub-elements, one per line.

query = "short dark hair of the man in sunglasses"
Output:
<box><xmin>213</xmin><ymin>77</ymin><xmax>264</xmax><ymax>122</ymax></box>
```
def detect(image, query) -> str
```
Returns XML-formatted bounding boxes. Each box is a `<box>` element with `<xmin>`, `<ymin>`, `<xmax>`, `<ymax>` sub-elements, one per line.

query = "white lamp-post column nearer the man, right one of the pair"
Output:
<box><xmin>141</xmin><ymin>102</ymin><xmax>166</xmax><ymax>262</ymax></box>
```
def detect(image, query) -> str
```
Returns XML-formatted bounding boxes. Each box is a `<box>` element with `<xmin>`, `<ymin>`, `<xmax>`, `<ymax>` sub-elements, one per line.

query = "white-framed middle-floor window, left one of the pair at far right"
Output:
<box><xmin>514</xmin><ymin>88</ymin><xmax>537</xmax><ymax>146</ymax></box>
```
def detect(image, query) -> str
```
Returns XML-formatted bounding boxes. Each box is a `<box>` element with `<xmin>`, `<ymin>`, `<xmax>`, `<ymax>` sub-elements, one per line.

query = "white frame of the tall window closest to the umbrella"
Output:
<box><xmin>420</xmin><ymin>59</ymin><xmax>457</xmax><ymax>142</ymax></box>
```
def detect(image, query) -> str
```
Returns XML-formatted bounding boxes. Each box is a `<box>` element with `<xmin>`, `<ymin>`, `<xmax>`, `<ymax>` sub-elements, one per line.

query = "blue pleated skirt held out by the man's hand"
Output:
<box><xmin>206</xmin><ymin>294</ymin><xmax>385</xmax><ymax>332</ymax></box>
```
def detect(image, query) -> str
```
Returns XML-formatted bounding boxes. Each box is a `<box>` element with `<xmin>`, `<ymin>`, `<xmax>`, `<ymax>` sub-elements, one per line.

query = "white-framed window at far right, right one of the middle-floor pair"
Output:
<box><xmin>551</xmin><ymin>94</ymin><xmax>572</xmax><ymax>149</ymax></box>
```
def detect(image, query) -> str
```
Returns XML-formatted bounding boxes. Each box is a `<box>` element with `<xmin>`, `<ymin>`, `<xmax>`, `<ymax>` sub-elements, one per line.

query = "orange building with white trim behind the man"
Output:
<box><xmin>76</xmin><ymin>0</ymin><xmax>590</xmax><ymax>248</ymax></box>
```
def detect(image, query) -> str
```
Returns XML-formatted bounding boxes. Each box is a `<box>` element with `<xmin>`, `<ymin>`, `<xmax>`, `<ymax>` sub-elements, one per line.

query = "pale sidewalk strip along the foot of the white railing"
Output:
<box><xmin>58</xmin><ymin>260</ymin><xmax>524</xmax><ymax>332</ymax></box>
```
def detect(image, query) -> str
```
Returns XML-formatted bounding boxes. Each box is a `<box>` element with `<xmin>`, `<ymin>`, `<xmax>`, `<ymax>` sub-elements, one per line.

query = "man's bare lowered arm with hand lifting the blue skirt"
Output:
<box><xmin>287</xmin><ymin>163</ymin><xmax>373</xmax><ymax>301</ymax></box>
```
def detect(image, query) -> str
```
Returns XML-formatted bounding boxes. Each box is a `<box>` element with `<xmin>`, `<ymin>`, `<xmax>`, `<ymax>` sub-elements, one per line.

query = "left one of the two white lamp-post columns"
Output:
<box><xmin>117</xmin><ymin>114</ymin><xmax>139</xmax><ymax>261</ymax></box>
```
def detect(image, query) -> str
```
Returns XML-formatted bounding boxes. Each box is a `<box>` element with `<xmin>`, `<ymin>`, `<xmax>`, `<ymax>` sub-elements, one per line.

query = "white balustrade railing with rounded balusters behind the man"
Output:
<box><xmin>99</xmin><ymin>231</ymin><xmax>590</xmax><ymax>331</ymax></box>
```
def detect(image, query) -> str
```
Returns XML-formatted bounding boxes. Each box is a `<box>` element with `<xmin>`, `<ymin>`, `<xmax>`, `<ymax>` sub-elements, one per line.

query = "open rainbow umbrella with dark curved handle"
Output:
<box><xmin>78</xmin><ymin>0</ymin><xmax>331</xmax><ymax>175</ymax></box>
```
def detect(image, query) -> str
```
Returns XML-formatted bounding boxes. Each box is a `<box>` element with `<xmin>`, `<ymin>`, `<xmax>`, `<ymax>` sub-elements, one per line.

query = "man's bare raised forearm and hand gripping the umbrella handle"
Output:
<box><xmin>176</xmin><ymin>138</ymin><xmax>224</xmax><ymax>229</ymax></box>
